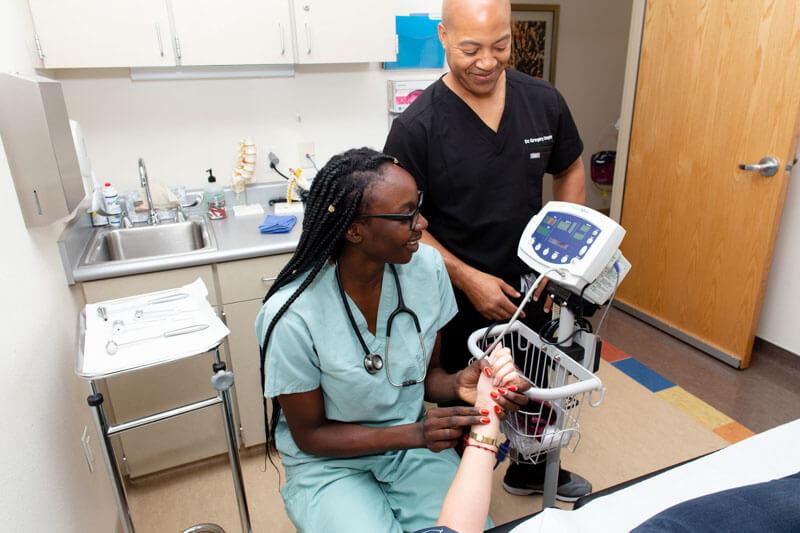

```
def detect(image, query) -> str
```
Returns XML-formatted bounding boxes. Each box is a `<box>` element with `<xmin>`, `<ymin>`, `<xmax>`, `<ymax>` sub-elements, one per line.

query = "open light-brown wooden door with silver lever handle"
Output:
<box><xmin>618</xmin><ymin>0</ymin><xmax>800</xmax><ymax>368</ymax></box>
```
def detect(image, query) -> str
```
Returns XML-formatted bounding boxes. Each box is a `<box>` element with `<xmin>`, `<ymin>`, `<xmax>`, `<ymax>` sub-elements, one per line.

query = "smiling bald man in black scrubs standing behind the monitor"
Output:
<box><xmin>384</xmin><ymin>0</ymin><xmax>591</xmax><ymax>501</ymax></box>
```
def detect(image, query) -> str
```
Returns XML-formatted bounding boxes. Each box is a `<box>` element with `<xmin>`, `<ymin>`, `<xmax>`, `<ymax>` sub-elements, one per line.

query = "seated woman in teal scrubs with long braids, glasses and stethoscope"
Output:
<box><xmin>256</xmin><ymin>148</ymin><xmax>525</xmax><ymax>533</ymax></box>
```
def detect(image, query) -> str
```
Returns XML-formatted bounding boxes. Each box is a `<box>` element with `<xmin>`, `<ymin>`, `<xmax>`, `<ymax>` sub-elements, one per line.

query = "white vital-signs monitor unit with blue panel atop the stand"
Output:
<box><xmin>517</xmin><ymin>202</ymin><xmax>631</xmax><ymax>305</ymax></box>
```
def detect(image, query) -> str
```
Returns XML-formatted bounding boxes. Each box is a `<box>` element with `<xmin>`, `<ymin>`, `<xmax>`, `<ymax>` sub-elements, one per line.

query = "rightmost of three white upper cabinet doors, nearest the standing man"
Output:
<box><xmin>294</xmin><ymin>0</ymin><xmax>397</xmax><ymax>64</ymax></box>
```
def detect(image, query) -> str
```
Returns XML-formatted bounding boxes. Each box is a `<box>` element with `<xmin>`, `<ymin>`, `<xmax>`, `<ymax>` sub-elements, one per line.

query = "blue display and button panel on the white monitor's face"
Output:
<box><xmin>531</xmin><ymin>211</ymin><xmax>600</xmax><ymax>264</ymax></box>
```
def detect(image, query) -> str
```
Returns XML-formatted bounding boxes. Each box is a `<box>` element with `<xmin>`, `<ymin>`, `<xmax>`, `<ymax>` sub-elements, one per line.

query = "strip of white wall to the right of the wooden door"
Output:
<box><xmin>756</xmin><ymin>146</ymin><xmax>800</xmax><ymax>356</ymax></box>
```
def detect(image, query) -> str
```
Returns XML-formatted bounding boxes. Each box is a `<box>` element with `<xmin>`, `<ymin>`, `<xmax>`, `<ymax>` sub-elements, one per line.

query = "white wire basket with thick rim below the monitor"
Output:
<box><xmin>468</xmin><ymin>322</ymin><xmax>603</xmax><ymax>464</ymax></box>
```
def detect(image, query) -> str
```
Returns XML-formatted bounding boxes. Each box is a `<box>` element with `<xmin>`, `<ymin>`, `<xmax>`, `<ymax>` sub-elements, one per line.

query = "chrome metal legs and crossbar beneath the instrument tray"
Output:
<box><xmin>86</xmin><ymin>345</ymin><xmax>252</xmax><ymax>533</ymax></box>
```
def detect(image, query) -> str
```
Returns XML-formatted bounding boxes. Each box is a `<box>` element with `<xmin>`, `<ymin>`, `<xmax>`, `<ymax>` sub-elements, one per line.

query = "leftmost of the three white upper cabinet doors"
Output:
<box><xmin>29</xmin><ymin>0</ymin><xmax>175</xmax><ymax>68</ymax></box>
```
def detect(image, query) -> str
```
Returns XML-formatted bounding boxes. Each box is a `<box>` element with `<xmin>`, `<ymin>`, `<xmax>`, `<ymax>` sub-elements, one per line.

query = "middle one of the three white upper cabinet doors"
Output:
<box><xmin>170</xmin><ymin>0</ymin><xmax>294</xmax><ymax>66</ymax></box>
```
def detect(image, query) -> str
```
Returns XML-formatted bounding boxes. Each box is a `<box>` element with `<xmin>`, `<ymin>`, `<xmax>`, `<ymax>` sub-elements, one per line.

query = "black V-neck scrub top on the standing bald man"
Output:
<box><xmin>383</xmin><ymin>69</ymin><xmax>583</xmax><ymax>279</ymax></box>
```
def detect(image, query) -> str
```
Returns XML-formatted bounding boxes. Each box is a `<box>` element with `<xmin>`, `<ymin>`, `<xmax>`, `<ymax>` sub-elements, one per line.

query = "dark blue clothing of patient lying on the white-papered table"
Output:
<box><xmin>633</xmin><ymin>472</ymin><xmax>800</xmax><ymax>533</ymax></box>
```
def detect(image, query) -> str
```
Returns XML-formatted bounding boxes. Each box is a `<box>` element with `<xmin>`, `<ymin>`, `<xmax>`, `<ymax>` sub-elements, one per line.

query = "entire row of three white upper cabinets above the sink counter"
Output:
<box><xmin>29</xmin><ymin>0</ymin><xmax>396</xmax><ymax>68</ymax></box>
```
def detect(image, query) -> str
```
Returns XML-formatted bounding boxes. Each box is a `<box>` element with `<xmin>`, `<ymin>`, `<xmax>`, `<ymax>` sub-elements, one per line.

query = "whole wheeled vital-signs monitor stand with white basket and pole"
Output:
<box><xmin>467</xmin><ymin>202</ymin><xmax>631</xmax><ymax>507</ymax></box>
